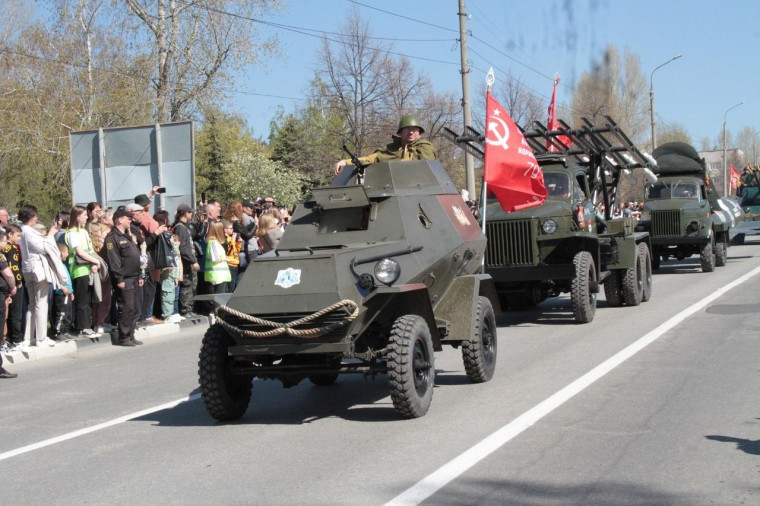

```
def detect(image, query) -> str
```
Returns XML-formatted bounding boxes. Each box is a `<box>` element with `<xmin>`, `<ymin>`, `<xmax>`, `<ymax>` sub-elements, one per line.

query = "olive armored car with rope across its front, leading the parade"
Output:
<box><xmin>198</xmin><ymin>160</ymin><xmax>500</xmax><ymax>420</ymax></box>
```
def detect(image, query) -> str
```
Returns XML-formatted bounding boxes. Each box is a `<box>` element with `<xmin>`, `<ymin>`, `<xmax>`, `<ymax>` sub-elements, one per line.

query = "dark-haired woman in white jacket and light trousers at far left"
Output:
<box><xmin>18</xmin><ymin>204</ymin><xmax>65</xmax><ymax>346</ymax></box>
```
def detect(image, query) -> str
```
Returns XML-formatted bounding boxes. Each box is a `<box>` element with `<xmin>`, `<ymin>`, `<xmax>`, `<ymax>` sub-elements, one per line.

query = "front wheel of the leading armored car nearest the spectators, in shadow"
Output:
<box><xmin>198</xmin><ymin>325</ymin><xmax>253</xmax><ymax>421</ymax></box>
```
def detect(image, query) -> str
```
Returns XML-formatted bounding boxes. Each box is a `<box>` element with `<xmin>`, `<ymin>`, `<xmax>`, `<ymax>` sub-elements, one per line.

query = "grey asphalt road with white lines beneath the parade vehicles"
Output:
<box><xmin>0</xmin><ymin>241</ymin><xmax>760</xmax><ymax>505</ymax></box>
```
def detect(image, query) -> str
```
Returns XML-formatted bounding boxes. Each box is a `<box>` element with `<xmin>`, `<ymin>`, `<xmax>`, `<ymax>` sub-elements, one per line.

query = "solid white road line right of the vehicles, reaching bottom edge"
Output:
<box><xmin>386</xmin><ymin>267</ymin><xmax>760</xmax><ymax>506</ymax></box>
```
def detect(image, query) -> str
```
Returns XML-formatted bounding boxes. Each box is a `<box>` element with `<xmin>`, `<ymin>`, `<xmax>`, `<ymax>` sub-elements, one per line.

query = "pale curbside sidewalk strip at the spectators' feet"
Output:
<box><xmin>3</xmin><ymin>316</ymin><xmax>208</xmax><ymax>365</ymax></box>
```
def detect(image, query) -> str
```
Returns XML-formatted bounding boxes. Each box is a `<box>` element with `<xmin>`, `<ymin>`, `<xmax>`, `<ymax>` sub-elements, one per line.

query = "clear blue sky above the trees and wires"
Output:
<box><xmin>232</xmin><ymin>0</ymin><xmax>760</xmax><ymax>152</ymax></box>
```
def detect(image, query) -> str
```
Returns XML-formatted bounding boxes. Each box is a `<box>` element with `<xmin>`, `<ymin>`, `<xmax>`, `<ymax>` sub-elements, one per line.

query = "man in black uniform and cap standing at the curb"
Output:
<box><xmin>104</xmin><ymin>209</ymin><xmax>142</xmax><ymax>346</ymax></box>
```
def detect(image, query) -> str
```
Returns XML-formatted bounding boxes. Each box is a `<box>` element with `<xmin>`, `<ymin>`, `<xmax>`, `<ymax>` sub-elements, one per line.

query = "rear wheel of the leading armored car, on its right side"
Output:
<box><xmin>462</xmin><ymin>297</ymin><xmax>497</xmax><ymax>383</ymax></box>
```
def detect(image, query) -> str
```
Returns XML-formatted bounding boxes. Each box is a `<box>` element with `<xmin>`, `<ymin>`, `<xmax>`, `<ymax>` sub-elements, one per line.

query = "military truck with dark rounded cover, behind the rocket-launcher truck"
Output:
<box><xmin>637</xmin><ymin>142</ymin><xmax>732</xmax><ymax>272</ymax></box>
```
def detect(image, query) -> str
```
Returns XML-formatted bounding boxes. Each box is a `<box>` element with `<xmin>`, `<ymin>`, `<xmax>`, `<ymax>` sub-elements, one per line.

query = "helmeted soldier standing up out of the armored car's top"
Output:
<box><xmin>335</xmin><ymin>114</ymin><xmax>437</xmax><ymax>174</ymax></box>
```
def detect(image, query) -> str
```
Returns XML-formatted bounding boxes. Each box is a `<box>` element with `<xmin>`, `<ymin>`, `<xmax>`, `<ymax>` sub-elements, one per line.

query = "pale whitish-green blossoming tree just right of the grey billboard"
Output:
<box><xmin>221</xmin><ymin>147</ymin><xmax>303</xmax><ymax>206</ymax></box>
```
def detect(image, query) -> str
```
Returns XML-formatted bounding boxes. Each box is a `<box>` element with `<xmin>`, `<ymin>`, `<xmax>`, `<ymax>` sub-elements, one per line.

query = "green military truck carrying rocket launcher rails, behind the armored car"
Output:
<box><xmin>447</xmin><ymin>117</ymin><xmax>653</xmax><ymax>323</ymax></box>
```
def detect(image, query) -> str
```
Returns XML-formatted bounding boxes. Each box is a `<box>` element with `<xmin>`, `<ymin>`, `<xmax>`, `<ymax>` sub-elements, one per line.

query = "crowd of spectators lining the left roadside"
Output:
<box><xmin>0</xmin><ymin>187</ymin><xmax>290</xmax><ymax>372</ymax></box>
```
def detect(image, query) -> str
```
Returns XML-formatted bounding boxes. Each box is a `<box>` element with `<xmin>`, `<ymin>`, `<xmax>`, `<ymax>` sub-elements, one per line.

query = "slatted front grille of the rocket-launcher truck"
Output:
<box><xmin>486</xmin><ymin>220</ymin><xmax>535</xmax><ymax>266</ymax></box>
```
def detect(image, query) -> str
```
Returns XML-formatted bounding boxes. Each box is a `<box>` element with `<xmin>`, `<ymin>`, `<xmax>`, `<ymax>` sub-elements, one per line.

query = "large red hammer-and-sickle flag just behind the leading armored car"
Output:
<box><xmin>483</xmin><ymin>90</ymin><xmax>546</xmax><ymax>213</ymax></box>
